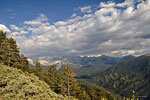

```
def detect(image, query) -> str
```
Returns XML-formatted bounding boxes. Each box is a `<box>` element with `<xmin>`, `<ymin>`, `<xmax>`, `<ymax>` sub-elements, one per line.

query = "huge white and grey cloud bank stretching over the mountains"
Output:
<box><xmin>8</xmin><ymin>0</ymin><xmax>150</xmax><ymax>57</ymax></box>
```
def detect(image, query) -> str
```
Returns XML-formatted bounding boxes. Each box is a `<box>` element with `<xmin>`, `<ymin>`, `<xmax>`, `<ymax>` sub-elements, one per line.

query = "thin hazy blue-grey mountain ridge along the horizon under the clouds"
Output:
<box><xmin>29</xmin><ymin>55</ymin><xmax>134</xmax><ymax>66</ymax></box>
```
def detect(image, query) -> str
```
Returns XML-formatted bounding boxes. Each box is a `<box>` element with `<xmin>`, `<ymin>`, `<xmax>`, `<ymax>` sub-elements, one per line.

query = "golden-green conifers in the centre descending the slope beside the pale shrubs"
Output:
<box><xmin>30</xmin><ymin>62</ymin><xmax>118</xmax><ymax>100</ymax></box>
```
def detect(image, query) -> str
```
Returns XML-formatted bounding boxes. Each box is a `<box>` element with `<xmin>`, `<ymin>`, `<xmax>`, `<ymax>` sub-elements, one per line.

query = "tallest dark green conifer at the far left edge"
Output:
<box><xmin>0</xmin><ymin>31</ymin><xmax>20</xmax><ymax>67</ymax></box>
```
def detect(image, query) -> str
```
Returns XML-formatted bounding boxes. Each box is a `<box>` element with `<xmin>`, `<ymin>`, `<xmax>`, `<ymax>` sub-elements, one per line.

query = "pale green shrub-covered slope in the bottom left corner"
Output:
<box><xmin>0</xmin><ymin>65</ymin><xmax>77</xmax><ymax>100</ymax></box>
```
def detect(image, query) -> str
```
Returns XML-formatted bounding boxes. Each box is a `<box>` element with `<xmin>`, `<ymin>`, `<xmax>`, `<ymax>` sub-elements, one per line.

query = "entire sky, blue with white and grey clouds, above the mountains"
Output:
<box><xmin>0</xmin><ymin>0</ymin><xmax>150</xmax><ymax>58</ymax></box>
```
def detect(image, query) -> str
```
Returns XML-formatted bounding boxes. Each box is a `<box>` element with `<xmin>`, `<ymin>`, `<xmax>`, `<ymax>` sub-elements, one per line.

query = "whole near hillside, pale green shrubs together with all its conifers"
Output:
<box><xmin>0</xmin><ymin>31</ymin><xmax>119</xmax><ymax>100</ymax></box>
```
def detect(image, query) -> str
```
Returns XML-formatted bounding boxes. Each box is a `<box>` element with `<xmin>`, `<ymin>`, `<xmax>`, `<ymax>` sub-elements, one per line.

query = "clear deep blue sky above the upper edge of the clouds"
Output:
<box><xmin>0</xmin><ymin>0</ymin><xmax>123</xmax><ymax>26</ymax></box>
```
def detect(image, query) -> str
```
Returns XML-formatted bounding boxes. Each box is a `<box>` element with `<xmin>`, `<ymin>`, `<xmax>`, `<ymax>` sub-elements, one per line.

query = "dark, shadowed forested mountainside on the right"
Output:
<box><xmin>89</xmin><ymin>55</ymin><xmax>150</xmax><ymax>97</ymax></box>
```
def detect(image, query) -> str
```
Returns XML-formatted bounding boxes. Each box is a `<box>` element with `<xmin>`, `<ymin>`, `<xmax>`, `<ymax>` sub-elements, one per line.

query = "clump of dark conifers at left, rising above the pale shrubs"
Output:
<box><xmin>0</xmin><ymin>31</ymin><xmax>29</xmax><ymax>71</ymax></box>
